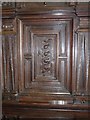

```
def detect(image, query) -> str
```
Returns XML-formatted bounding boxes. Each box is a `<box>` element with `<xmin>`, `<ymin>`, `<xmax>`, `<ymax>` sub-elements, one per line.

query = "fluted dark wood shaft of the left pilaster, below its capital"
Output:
<box><xmin>2</xmin><ymin>35</ymin><xmax>15</xmax><ymax>91</ymax></box>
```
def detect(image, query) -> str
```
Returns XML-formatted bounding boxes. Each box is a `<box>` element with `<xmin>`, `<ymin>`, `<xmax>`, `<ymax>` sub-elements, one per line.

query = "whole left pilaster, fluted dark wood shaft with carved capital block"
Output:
<box><xmin>2</xmin><ymin>19</ymin><xmax>18</xmax><ymax>99</ymax></box>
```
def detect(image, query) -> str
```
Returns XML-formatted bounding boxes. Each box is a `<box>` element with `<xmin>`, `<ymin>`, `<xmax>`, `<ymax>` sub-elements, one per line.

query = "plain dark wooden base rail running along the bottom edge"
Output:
<box><xmin>3</xmin><ymin>102</ymin><xmax>89</xmax><ymax>120</ymax></box>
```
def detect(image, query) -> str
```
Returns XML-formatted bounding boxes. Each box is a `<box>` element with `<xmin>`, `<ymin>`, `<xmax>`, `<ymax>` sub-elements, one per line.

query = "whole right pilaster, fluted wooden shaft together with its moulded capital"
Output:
<box><xmin>73</xmin><ymin>17</ymin><xmax>90</xmax><ymax>95</ymax></box>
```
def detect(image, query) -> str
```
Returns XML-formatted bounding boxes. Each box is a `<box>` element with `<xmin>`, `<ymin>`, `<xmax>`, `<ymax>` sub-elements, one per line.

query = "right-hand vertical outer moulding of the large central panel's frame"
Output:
<box><xmin>65</xmin><ymin>22</ymin><xmax>72</xmax><ymax>91</ymax></box>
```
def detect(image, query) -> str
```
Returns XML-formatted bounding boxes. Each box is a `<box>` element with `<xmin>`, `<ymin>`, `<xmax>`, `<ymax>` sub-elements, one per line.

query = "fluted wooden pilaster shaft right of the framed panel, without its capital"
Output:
<box><xmin>73</xmin><ymin>30</ymin><xmax>90</xmax><ymax>95</ymax></box>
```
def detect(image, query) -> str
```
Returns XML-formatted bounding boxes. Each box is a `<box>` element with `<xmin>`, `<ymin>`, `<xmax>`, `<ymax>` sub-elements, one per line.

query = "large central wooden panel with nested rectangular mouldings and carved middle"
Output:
<box><xmin>18</xmin><ymin>19</ymin><xmax>72</xmax><ymax>101</ymax></box>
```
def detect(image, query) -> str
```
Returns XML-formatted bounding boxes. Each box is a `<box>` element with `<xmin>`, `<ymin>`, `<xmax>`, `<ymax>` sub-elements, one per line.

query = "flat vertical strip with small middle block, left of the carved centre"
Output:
<box><xmin>23</xmin><ymin>26</ymin><xmax>32</xmax><ymax>88</ymax></box>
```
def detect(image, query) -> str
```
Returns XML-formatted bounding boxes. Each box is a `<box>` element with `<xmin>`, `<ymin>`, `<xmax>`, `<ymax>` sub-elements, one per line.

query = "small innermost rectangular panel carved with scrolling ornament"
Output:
<box><xmin>33</xmin><ymin>33</ymin><xmax>57</xmax><ymax>79</ymax></box>
